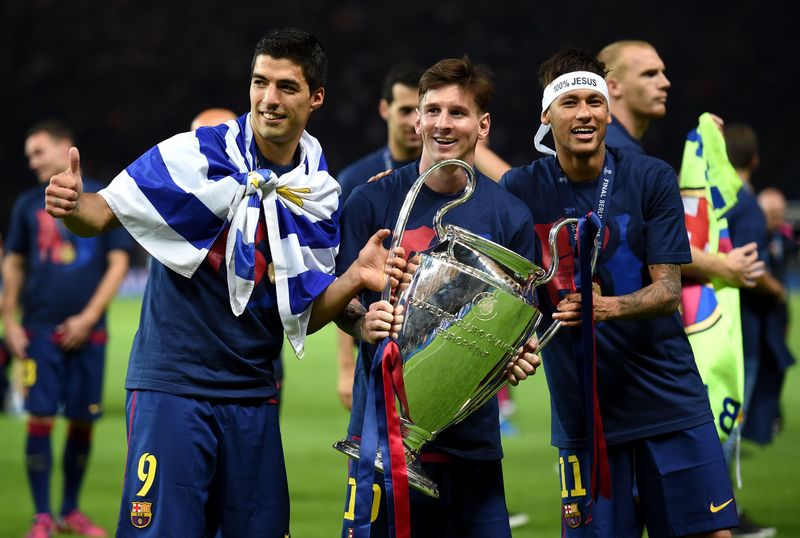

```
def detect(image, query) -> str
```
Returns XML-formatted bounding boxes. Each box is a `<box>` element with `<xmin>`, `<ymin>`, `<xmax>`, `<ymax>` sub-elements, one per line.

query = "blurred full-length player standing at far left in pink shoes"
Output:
<box><xmin>3</xmin><ymin>121</ymin><xmax>133</xmax><ymax>538</ymax></box>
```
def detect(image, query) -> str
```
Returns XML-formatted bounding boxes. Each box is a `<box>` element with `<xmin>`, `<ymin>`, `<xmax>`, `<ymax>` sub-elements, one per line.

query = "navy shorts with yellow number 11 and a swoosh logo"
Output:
<box><xmin>558</xmin><ymin>422</ymin><xmax>738</xmax><ymax>538</ymax></box>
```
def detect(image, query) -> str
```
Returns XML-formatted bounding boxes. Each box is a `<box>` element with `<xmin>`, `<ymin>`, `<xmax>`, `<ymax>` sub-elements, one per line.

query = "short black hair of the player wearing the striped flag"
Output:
<box><xmin>250</xmin><ymin>28</ymin><xmax>328</xmax><ymax>92</ymax></box>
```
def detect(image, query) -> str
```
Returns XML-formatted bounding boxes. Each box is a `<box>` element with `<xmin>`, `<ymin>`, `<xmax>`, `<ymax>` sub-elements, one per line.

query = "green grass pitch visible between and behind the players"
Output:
<box><xmin>0</xmin><ymin>295</ymin><xmax>800</xmax><ymax>538</ymax></box>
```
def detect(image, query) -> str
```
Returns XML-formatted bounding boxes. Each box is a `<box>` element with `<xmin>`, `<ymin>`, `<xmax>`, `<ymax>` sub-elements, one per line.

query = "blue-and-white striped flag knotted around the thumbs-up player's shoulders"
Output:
<box><xmin>100</xmin><ymin>113</ymin><xmax>340</xmax><ymax>357</ymax></box>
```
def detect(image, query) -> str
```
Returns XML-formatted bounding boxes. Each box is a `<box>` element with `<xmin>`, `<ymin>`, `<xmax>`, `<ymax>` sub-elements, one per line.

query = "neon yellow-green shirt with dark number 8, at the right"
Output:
<box><xmin>680</xmin><ymin>113</ymin><xmax>744</xmax><ymax>441</ymax></box>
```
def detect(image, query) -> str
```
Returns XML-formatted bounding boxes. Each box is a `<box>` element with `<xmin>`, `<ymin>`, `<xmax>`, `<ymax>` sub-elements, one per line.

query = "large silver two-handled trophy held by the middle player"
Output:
<box><xmin>333</xmin><ymin>159</ymin><xmax>577</xmax><ymax>497</ymax></box>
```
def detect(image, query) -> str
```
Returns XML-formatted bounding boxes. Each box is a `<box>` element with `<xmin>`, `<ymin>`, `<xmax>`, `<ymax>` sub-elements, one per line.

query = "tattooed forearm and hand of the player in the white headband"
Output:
<box><xmin>553</xmin><ymin>264</ymin><xmax>681</xmax><ymax>327</ymax></box>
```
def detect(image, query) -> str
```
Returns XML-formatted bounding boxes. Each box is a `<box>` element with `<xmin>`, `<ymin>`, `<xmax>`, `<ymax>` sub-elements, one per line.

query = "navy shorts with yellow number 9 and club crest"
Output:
<box><xmin>117</xmin><ymin>391</ymin><xmax>289</xmax><ymax>538</ymax></box>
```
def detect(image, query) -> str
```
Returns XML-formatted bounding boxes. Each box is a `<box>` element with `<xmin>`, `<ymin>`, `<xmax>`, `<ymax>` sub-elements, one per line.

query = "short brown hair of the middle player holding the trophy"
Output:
<box><xmin>419</xmin><ymin>56</ymin><xmax>494</xmax><ymax>112</ymax></box>
